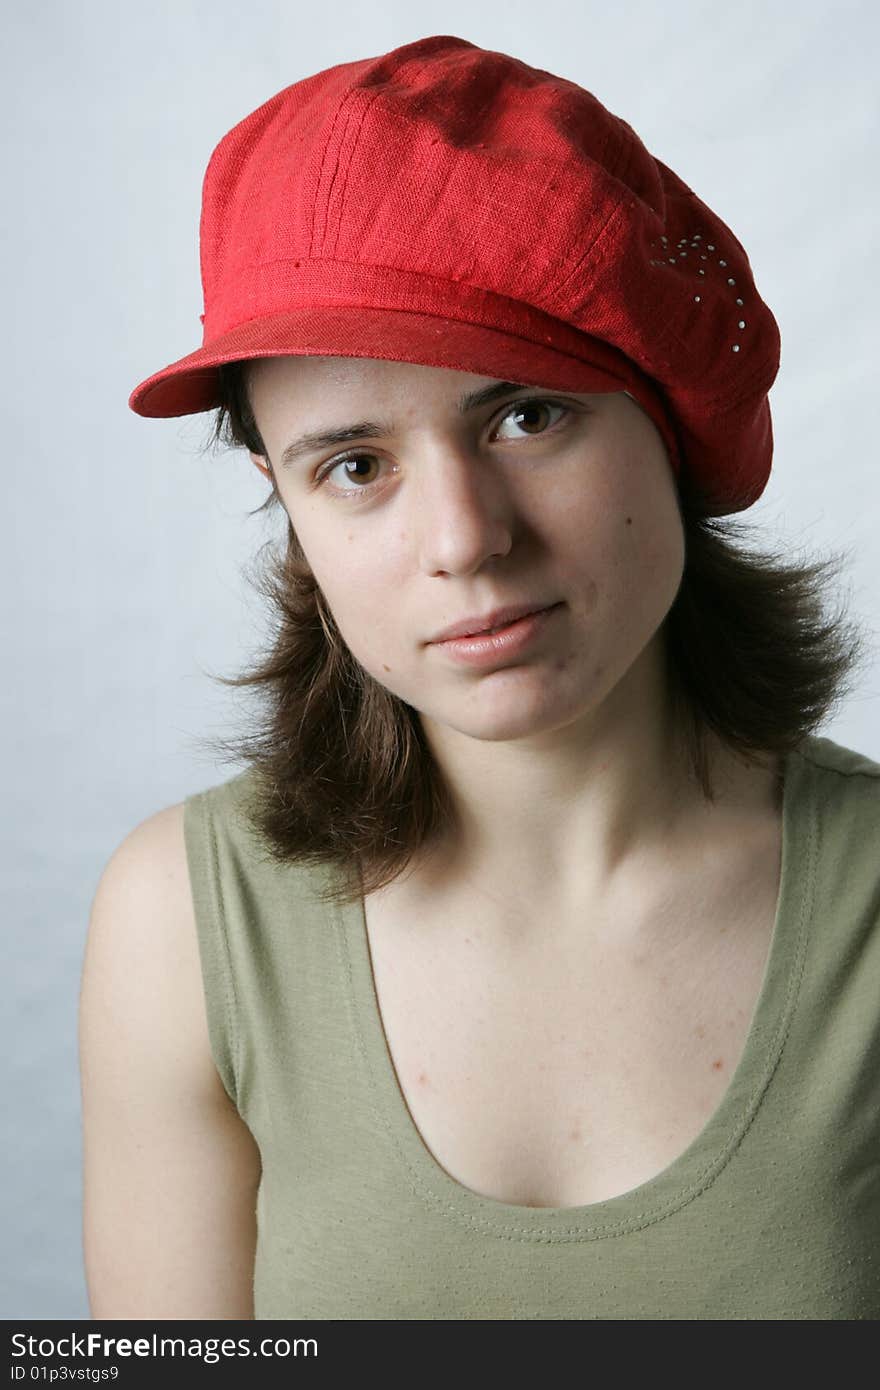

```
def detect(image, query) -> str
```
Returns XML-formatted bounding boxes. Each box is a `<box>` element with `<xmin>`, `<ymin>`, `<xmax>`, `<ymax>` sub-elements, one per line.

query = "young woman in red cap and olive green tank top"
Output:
<box><xmin>81</xmin><ymin>36</ymin><xmax>880</xmax><ymax>1319</ymax></box>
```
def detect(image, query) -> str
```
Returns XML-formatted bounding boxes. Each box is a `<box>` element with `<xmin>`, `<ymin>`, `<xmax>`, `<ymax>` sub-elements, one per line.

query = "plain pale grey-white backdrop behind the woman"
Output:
<box><xmin>0</xmin><ymin>0</ymin><xmax>880</xmax><ymax>1319</ymax></box>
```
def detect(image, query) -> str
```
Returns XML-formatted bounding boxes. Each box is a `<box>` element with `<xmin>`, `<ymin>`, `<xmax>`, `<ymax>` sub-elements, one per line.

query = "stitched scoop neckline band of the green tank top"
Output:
<box><xmin>336</xmin><ymin>737</ymin><xmax>817</xmax><ymax>1241</ymax></box>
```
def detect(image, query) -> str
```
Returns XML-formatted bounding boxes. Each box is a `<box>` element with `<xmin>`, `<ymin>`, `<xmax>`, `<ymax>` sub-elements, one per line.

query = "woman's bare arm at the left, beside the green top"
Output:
<box><xmin>79</xmin><ymin>803</ymin><xmax>260</xmax><ymax>1319</ymax></box>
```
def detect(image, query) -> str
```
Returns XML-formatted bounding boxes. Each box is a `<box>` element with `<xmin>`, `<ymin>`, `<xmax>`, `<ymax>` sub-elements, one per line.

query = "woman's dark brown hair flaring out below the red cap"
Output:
<box><xmin>191</xmin><ymin>353</ymin><xmax>865</xmax><ymax>904</ymax></box>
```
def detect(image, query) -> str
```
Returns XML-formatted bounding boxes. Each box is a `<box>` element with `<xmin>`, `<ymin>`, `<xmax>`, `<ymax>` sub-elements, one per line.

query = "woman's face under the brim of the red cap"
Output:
<box><xmin>243</xmin><ymin>357</ymin><xmax>684</xmax><ymax>739</ymax></box>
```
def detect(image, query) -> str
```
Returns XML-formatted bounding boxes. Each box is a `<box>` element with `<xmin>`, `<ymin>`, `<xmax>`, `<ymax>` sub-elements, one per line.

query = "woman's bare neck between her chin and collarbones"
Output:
<box><xmin>408</xmin><ymin>652</ymin><xmax>779</xmax><ymax>915</ymax></box>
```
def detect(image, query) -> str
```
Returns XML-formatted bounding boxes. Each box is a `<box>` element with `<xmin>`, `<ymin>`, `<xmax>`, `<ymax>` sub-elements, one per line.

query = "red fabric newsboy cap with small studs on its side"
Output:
<box><xmin>129</xmin><ymin>35</ymin><xmax>780</xmax><ymax>514</ymax></box>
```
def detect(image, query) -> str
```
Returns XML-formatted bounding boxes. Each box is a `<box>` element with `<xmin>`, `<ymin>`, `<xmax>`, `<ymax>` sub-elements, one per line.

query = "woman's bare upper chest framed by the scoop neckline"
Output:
<box><xmin>366</xmin><ymin>844</ymin><xmax>780</xmax><ymax>1207</ymax></box>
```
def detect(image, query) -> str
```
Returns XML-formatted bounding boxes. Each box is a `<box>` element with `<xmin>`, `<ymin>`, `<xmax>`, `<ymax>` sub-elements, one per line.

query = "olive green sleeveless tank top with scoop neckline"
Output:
<box><xmin>185</xmin><ymin>737</ymin><xmax>880</xmax><ymax>1319</ymax></box>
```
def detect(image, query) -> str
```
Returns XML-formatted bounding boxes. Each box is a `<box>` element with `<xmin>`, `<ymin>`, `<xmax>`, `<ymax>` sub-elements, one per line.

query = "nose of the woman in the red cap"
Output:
<box><xmin>414</xmin><ymin>442</ymin><xmax>514</xmax><ymax>574</ymax></box>
